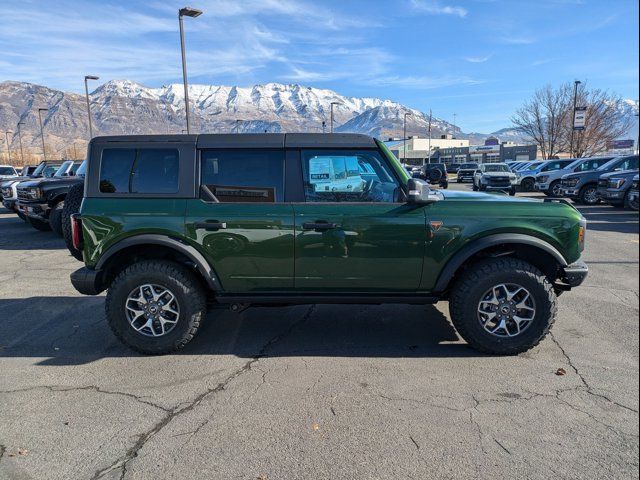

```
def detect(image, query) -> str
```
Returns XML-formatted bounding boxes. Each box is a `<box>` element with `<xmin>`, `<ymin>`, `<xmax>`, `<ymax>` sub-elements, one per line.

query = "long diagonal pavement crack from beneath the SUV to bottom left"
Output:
<box><xmin>91</xmin><ymin>305</ymin><xmax>316</xmax><ymax>480</ymax></box>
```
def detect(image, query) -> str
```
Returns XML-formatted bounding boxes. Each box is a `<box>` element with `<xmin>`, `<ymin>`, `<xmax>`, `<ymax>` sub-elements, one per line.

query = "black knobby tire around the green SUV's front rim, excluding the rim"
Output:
<box><xmin>449</xmin><ymin>257</ymin><xmax>557</xmax><ymax>355</ymax></box>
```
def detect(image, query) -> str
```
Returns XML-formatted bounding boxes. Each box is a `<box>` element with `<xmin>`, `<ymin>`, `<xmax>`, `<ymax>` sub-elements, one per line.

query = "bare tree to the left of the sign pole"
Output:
<box><xmin>511</xmin><ymin>84</ymin><xmax>571</xmax><ymax>159</ymax></box>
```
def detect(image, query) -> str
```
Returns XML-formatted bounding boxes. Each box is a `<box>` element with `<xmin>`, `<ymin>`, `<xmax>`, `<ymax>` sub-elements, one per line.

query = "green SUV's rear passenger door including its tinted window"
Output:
<box><xmin>185</xmin><ymin>149</ymin><xmax>294</xmax><ymax>293</ymax></box>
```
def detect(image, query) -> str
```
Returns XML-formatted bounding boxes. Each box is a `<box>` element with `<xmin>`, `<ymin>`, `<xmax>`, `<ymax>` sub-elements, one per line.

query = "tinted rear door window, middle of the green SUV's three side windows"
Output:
<box><xmin>202</xmin><ymin>150</ymin><xmax>284</xmax><ymax>202</ymax></box>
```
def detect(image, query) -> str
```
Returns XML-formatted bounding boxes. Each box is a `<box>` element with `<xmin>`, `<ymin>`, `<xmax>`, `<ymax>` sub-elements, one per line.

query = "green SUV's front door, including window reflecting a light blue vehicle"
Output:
<box><xmin>293</xmin><ymin>150</ymin><xmax>426</xmax><ymax>293</ymax></box>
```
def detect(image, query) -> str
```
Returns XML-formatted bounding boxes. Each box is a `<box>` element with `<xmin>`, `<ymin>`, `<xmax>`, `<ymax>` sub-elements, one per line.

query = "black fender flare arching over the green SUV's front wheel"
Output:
<box><xmin>433</xmin><ymin>233</ymin><xmax>568</xmax><ymax>293</ymax></box>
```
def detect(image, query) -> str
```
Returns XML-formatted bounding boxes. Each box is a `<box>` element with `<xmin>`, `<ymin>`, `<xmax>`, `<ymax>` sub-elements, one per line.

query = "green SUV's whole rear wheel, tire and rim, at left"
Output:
<box><xmin>105</xmin><ymin>260</ymin><xmax>206</xmax><ymax>355</ymax></box>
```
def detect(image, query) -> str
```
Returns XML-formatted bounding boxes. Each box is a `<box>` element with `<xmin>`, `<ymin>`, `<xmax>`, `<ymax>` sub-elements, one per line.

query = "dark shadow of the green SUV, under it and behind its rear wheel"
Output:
<box><xmin>0</xmin><ymin>297</ymin><xmax>483</xmax><ymax>366</ymax></box>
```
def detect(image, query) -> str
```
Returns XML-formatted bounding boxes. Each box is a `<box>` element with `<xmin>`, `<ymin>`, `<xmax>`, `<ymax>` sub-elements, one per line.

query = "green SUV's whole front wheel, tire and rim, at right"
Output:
<box><xmin>449</xmin><ymin>257</ymin><xmax>557</xmax><ymax>355</ymax></box>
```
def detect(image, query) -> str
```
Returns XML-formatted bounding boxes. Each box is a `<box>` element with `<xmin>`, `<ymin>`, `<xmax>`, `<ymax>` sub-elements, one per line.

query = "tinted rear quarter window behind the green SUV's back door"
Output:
<box><xmin>100</xmin><ymin>148</ymin><xmax>180</xmax><ymax>194</ymax></box>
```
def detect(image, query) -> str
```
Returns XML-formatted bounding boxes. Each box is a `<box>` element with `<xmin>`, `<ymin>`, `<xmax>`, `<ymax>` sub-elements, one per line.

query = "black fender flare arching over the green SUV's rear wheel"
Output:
<box><xmin>95</xmin><ymin>234</ymin><xmax>222</xmax><ymax>292</ymax></box>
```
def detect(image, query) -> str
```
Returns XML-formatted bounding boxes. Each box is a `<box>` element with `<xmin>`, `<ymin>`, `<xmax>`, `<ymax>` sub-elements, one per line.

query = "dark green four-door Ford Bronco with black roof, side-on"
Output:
<box><xmin>71</xmin><ymin>133</ymin><xmax>587</xmax><ymax>354</ymax></box>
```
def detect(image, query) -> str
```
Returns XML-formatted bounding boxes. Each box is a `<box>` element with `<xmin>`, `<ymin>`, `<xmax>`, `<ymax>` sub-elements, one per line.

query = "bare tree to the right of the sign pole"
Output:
<box><xmin>563</xmin><ymin>85</ymin><xmax>632</xmax><ymax>157</ymax></box>
